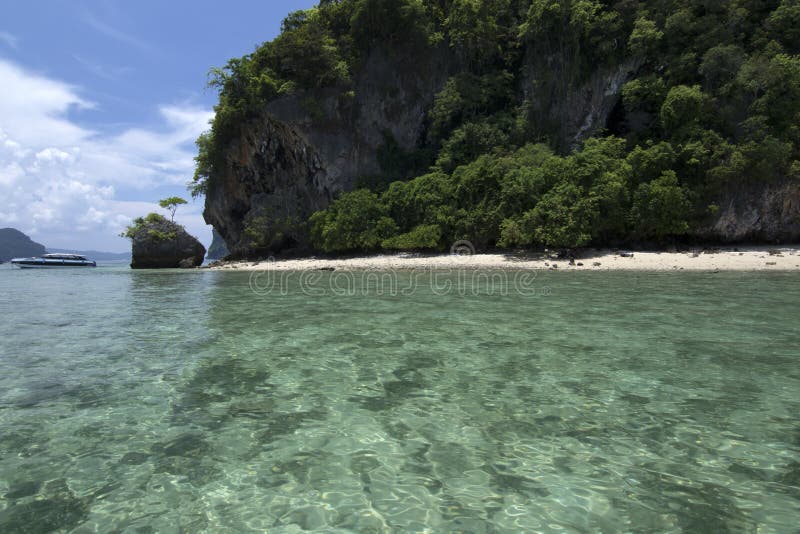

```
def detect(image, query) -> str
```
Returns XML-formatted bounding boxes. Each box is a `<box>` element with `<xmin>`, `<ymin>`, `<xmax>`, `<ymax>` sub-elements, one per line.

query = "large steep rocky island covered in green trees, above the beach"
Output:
<box><xmin>193</xmin><ymin>1</ymin><xmax>800</xmax><ymax>266</ymax></box>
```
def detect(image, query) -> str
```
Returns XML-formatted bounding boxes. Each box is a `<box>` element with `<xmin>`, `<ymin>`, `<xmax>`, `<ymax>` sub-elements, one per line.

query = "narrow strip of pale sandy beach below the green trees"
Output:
<box><xmin>209</xmin><ymin>246</ymin><xmax>800</xmax><ymax>271</ymax></box>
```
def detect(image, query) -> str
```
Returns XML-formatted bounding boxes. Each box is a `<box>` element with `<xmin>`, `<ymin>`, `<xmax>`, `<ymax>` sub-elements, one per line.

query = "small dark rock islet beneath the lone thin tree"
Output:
<box><xmin>130</xmin><ymin>217</ymin><xmax>206</xmax><ymax>269</ymax></box>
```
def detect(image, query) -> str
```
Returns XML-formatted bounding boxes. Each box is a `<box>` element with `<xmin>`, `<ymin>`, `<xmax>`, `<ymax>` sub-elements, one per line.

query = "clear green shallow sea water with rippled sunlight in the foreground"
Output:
<box><xmin>0</xmin><ymin>268</ymin><xmax>800</xmax><ymax>532</ymax></box>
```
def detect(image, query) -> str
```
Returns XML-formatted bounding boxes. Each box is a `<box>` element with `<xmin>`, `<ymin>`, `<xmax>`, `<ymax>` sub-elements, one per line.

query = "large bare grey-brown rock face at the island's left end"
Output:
<box><xmin>203</xmin><ymin>48</ymin><xmax>452</xmax><ymax>257</ymax></box>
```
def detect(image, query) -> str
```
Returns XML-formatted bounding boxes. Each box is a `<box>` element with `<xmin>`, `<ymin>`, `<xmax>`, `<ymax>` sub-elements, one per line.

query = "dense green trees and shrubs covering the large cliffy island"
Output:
<box><xmin>195</xmin><ymin>0</ymin><xmax>800</xmax><ymax>252</ymax></box>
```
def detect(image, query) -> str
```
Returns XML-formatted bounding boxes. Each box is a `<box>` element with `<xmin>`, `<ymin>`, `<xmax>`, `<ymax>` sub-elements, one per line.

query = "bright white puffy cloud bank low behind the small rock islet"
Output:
<box><xmin>0</xmin><ymin>60</ymin><xmax>212</xmax><ymax>250</ymax></box>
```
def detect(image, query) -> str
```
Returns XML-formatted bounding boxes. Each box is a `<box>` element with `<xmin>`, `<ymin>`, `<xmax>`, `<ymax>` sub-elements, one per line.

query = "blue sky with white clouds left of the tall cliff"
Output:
<box><xmin>0</xmin><ymin>0</ymin><xmax>316</xmax><ymax>252</ymax></box>
